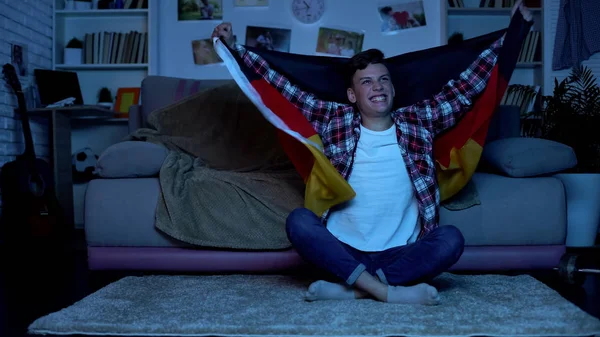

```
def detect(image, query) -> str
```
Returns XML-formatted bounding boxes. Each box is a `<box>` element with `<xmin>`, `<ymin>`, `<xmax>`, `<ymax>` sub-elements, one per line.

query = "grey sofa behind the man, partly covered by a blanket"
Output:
<box><xmin>84</xmin><ymin>76</ymin><xmax>573</xmax><ymax>273</ymax></box>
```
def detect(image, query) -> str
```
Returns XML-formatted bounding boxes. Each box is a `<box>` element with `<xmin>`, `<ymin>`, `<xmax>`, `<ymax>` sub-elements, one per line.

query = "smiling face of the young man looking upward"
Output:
<box><xmin>347</xmin><ymin>63</ymin><xmax>395</xmax><ymax>117</ymax></box>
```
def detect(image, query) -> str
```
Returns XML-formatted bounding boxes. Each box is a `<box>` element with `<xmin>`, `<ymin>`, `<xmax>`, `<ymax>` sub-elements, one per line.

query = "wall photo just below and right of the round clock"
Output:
<box><xmin>316</xmin><ymin>27</ymin><xmax>365</xmax><ymax>57</ymax></box>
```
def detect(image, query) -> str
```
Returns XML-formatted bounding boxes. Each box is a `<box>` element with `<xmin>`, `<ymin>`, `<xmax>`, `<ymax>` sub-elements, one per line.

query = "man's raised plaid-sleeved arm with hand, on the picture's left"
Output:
<box><xmin>213</xmin><ymin>23</ymin><xmax>341</xmax><ymax>133</ymax></box>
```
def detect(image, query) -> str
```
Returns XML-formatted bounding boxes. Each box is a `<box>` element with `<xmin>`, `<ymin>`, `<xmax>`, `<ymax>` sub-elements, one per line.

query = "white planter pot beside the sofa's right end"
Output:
<box><xmin>555</xmin><ymin>173</ymin><xmax>600</xmax><ymax>247</ymax></box>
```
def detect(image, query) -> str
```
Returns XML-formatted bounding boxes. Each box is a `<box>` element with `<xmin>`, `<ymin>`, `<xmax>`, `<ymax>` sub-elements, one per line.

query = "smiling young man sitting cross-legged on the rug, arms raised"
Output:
<box><xmin>212</xmin><ymin>1</ymin><xmax>532</xmax><ymax>305</ymax></box>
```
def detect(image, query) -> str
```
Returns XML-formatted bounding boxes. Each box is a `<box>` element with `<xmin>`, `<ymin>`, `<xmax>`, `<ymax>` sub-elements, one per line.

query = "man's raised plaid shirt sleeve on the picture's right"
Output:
<box><xmin>403</xmin><ymin>37</ymin><xmax>504</xmax><ymax>135</ymax></box>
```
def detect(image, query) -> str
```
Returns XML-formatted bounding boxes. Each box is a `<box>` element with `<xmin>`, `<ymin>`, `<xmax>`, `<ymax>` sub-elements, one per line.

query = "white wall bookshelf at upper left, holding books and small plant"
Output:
<box><xmin>52</xmin><ymin>0</ymin><xmax>158</xmax><ymax>104</ymax></box>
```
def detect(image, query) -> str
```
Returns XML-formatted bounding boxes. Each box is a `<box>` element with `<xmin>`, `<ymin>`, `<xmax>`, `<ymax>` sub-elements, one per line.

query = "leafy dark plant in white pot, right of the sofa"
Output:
<box><xmin>506</xmin><ymin>65</ymin><xmax>600</xmax><ymax>246</ymax></box>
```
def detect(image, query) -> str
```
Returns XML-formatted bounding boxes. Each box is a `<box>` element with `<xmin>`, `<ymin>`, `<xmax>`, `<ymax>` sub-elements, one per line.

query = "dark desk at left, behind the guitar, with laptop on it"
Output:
<box><xmin>28</xmin><ymin>105</ymin><xmax>128</xmax><ymax>226</ymax></box>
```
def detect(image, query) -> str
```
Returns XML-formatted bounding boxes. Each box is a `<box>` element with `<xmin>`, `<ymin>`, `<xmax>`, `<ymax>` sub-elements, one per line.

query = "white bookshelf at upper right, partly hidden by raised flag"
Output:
<box><xmin>445</xmin><ymin>0</ymin><xmax>545</xmax><ymax>120</ymax></box>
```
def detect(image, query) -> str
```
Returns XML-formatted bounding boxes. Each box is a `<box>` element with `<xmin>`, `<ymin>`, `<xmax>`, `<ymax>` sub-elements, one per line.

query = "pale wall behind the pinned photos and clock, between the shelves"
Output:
<box><xmin>158</xmin><ymin>0</ymin><xmax>446</xmax><ymax>79</ymax></box>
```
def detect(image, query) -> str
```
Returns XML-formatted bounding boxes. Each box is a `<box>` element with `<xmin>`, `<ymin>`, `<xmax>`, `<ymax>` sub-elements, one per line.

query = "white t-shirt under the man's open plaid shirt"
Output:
<box><xmin>327</xmin><ymin>125</ymin><xmax>421</xmax><ymax>252</ymax></box>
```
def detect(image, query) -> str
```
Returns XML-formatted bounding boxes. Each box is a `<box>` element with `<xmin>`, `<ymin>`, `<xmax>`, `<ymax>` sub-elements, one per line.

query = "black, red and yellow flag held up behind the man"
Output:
<box><xmin>214</xmin><ymin>12</ymin><xmax>532</xmax><ymax>216</ymax></box>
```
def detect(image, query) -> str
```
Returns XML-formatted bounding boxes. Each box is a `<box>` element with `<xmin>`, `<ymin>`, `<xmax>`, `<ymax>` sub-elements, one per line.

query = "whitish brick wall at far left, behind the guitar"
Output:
<box><xmin>0</xmin><ymin>0</ymin><xmax>54</xmax><ymax>212</ymax></box>
